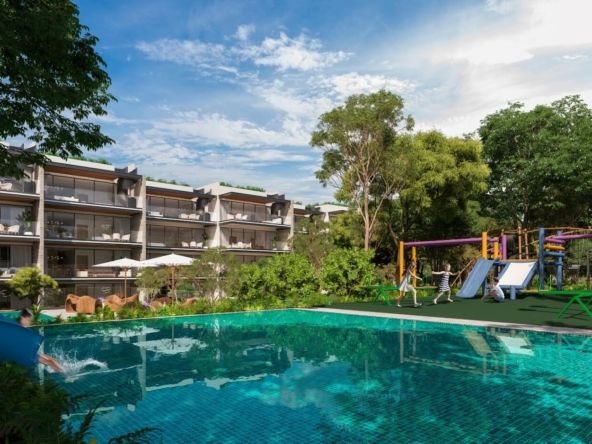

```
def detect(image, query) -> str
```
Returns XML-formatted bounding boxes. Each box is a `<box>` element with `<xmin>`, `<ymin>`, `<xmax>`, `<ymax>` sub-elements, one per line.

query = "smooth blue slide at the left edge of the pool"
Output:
<box><xmin>0</xmin><ymin>316</ymin><xmax>43</xmax><ymax>369</ymax></box>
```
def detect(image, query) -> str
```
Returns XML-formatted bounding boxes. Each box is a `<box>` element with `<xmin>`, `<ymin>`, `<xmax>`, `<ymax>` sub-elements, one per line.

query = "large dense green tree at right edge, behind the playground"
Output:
<box><xmin>478</xmin><ymin>96</ymin><xmax>592</xmax><ymax>229</ymax></box>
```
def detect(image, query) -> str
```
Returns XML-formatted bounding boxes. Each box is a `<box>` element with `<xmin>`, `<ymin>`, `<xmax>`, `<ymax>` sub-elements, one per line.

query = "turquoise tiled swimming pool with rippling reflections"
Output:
<box><xmin>37</xmin><ymin>310</ymin><xmax>592</xmax><ymax>443</ymax></box>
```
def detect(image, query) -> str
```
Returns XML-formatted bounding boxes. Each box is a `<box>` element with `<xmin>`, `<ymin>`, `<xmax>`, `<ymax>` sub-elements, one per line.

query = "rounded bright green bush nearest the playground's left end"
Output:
<box><xmin>320</xmin><ymin>248</ymin><xmax>376</xmax><ymax>297</ymax></box>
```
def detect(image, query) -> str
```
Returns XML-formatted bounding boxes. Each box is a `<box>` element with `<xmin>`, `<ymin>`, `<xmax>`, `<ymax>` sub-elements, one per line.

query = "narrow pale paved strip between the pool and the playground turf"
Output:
<box><xmin>306</xmin><ymin>307</ymin><xmax>592</xmax><ymax>336</ymax></box>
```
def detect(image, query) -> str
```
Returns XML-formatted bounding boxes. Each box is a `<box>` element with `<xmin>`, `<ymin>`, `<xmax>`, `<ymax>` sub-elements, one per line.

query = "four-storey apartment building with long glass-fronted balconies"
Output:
<box><xmin>0</xmin><ymin>147</ymin><xmax>332</xmax><ymax>308</ymax></box>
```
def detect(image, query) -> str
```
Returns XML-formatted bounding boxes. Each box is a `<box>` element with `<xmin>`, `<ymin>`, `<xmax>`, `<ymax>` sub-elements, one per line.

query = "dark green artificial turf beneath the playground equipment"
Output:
<box><xmin>330</xmin><ymin>294</ymin><xmax>592</xmax><ymax>329</ymax></box>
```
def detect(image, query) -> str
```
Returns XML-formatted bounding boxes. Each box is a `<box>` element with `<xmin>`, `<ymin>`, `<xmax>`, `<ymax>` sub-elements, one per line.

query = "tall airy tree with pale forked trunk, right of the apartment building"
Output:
<box><xmin>310</xmin><ymin>90</ymin><xmax>413</xmax><ymax>251</ymax></box>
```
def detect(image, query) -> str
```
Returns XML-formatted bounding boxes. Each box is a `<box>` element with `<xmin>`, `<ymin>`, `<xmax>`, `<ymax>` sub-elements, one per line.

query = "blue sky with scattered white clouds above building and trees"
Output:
<box><xmin>67</xmin><ymin>0</ymin><xmax>592</xmax><ymax>202</ymax></box>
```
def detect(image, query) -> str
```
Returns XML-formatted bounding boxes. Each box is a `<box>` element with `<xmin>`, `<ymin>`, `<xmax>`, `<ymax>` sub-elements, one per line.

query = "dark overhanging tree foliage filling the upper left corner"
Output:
<box><xmin>0</xmin><ymin>0</ymin><xmax>115</xmax><ymax>179</ymax></box>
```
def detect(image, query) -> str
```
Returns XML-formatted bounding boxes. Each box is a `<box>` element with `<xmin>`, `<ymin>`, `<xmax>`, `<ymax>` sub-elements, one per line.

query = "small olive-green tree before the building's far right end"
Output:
<box><xmin>290</xmin><ymin>217</ymin><xmax>333</xmax><ymax>270</ymax></box>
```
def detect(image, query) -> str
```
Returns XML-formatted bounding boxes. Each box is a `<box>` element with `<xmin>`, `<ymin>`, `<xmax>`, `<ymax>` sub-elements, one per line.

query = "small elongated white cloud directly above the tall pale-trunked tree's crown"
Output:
<box><xmin>319</xmin><ymin>72</ymin><xmax>417</xmax><ymax>98</ymax></box>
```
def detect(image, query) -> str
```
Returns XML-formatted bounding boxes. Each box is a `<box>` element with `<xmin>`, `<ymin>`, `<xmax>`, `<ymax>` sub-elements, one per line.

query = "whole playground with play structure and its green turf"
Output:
<box><xmin>346</xmin><ymin>227</ymin><xmax>592</xmax><ymax>329</ymax></box>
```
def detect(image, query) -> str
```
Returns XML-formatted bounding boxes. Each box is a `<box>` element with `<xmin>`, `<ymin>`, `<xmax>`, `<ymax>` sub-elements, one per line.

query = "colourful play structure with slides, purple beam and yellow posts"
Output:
<box><xmin>399</xmin><ymin>227</ymin><xmax>592</xmax><ymax>306</ymax></box>
